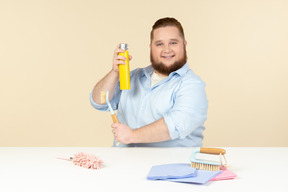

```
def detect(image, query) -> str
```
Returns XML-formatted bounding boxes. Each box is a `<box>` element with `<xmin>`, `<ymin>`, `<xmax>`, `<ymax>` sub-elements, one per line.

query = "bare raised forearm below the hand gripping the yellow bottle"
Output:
<box><xmin>92</xmin><ymin>70</ymin><xmax>119</xmax><ymax>104</ymax></box>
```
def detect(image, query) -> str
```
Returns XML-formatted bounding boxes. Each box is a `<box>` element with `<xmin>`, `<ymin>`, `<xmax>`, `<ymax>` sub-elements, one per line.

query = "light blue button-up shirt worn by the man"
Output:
<box><xmin>90</xmin><ymin>63</ymin><xmax>208</xmax><ymax>147</ymax></box>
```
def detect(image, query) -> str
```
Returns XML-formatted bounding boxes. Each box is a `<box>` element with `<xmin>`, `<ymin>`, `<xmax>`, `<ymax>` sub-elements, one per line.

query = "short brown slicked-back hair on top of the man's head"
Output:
<box><xmin>150</xmin><ymin>17</ymin><xmax>185</xmax><ymax>42</ymax></box>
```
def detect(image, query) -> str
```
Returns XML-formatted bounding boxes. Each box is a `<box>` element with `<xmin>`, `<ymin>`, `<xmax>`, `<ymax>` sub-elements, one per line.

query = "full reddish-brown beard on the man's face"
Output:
<box><xmin>150</xmin><ymin>47</ymin><xmax>187</xmax><ymax>76</ymax></box>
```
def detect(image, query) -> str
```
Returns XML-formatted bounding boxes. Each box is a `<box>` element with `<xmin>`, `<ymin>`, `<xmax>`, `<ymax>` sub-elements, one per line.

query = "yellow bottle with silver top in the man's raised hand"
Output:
<box><xmin>119</xmin><ymin>43</ymin><xmax>130</xmax><ymax>90</ymax></box>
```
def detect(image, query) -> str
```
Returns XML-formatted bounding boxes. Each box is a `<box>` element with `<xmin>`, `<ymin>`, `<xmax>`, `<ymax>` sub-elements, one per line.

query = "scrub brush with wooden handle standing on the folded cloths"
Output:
<box><xmin>190</xmin><ymin>147</ymin><xmax>227</xmax><ymax>171</ymax></box>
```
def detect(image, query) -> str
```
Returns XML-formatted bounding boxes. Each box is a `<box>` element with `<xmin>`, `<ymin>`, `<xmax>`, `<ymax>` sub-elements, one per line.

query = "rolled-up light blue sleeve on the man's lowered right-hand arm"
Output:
<box><xmin>164</xmin><ymin>79</ymin><xmax>208</xmax><ymax>139</ymax></box>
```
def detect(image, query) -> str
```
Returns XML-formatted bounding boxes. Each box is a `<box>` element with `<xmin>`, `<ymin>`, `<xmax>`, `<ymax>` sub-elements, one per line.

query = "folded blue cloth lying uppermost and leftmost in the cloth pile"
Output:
<box><xmin>147</xmin><ymin>163</ymin><xmax>196</xmax><ymax>180</ymax></box>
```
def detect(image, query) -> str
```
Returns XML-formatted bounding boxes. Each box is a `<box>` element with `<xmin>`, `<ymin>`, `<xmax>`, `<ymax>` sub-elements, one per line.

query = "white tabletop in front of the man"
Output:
<box><xmin>0</xmin><ymin>147</ymin><xmax>288</xmax><ymax>192</ymax></box>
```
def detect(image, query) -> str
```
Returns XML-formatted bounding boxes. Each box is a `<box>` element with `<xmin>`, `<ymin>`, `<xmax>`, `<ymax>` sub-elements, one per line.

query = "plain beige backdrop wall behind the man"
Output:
<box><xmin>0</xmin><ymin>0</ymin><xmax>288</xmax><ymax>147</ymax></box>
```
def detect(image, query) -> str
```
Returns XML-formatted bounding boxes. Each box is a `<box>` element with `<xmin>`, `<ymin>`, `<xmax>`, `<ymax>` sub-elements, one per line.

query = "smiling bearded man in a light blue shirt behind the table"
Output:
<box><xmin>90</xmin><ymin>17</ymin><xmax>208</xmax><ymax>147</ymax></box>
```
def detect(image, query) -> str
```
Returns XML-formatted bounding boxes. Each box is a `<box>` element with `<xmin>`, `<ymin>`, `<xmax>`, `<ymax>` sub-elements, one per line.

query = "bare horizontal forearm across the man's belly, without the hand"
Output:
<box><xmin>132</xmin><ymin>118</ymin><xmax>171</xmax><ymax>143</ymax></box>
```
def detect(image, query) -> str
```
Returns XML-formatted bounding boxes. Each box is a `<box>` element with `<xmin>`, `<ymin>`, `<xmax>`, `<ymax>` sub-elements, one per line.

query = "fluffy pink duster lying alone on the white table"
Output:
<box><xmin>57</xmin><ymin>152</ymin><xmax>103</xmax><ymax>169</ymax></box>
